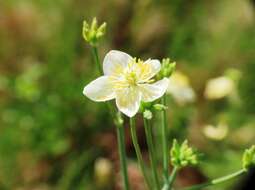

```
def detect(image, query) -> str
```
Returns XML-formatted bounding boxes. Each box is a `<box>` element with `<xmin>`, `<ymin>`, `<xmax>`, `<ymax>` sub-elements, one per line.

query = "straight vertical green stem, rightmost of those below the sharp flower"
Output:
<box><xmin>161</xmin><ymin>95</ymin><xmax>169</xmax><ymax>182</ymax></box>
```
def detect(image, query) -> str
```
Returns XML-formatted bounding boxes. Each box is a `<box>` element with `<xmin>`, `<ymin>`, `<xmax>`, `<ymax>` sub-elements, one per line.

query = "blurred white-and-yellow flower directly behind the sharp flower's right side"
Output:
<box><xmin>167</xmin><ymin>71</ymin><xmax>196</xmax><ymax>105</ymax></box>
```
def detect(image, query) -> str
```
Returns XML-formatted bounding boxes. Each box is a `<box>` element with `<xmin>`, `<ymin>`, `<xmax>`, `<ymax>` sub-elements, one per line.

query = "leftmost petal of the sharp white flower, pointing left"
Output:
<box><xmin>83</xmin><ymin>76</ymin><xmax>115</xmax><ymax>102</ymax></box>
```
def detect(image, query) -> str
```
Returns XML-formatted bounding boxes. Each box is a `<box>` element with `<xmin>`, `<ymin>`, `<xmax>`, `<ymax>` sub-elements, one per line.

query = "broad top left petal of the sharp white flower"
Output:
<box><xmin>103</xmin><ymin>50</ymin><xmax>132</xmax><ymax>75</ymax></box>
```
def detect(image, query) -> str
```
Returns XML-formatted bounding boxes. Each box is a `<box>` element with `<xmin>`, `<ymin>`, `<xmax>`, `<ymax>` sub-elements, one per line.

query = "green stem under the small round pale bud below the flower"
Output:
<box><xmin>143</xmin><ymin>118</ymin><xmax>160</xmax><ymax>190</ymax></box>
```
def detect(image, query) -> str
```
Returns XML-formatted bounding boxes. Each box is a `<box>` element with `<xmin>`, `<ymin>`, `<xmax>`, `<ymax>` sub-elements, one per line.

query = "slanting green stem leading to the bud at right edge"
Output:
<box><xmin>183</xmin><ymin>169</ymin><xmax>246</xmax><ymax>190</ymax></box>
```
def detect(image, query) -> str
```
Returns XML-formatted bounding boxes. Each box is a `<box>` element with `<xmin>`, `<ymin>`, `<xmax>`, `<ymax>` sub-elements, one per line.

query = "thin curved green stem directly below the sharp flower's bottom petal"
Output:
<box><xmin>130</xmin><ymin>117</ymin><xmax>151</xmax><ymax>189</ymax></box>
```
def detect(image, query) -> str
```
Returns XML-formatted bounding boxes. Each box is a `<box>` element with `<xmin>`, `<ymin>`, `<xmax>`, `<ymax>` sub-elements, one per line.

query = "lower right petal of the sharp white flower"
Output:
<box><xmin>139</xmin><ymin>78</ymin><xmax>169</xmax><ymax>102</ymax></box>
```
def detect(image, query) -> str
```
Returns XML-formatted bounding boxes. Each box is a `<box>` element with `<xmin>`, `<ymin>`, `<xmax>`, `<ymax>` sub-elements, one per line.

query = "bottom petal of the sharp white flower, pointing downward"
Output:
<box><xmin>116</xmin><ymin>87</ymin><xmax>141</xmax><ymax>117</ymax></box>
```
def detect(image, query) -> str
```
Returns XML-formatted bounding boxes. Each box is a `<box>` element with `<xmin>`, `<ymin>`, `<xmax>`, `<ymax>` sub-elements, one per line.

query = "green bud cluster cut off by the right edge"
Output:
<box><xmin>243</xmin><ymin>145</ymin><xmax>255</xmax><ymax>171</ymax></box>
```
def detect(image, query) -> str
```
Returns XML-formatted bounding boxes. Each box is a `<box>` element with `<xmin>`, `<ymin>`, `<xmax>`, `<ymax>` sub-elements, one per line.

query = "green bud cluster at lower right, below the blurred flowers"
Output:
<box><xmin>170</xmin><ymin>139</ymin><xmax>198</xmax><ymax>168</ymax></box>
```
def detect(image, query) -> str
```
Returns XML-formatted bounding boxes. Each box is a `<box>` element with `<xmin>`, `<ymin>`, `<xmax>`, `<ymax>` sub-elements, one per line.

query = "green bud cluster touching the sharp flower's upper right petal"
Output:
<box><xmin>157</xmin><ymin>58</ymin><xmax>176</xmax><ymax>80</ymax></box>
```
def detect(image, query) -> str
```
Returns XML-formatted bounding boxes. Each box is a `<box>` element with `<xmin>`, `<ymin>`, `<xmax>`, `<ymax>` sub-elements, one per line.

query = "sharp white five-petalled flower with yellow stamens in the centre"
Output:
<box><xmin>83</xmin><ymin>50</ymin><xmax>168</xmax><ymax>117</ymax></box>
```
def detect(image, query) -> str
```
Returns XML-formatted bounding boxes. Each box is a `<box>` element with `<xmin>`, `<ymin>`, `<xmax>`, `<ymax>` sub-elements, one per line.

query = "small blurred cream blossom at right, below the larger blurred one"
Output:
<box><xmin>203</xmin><ymin>122</ymin><xmax>228</xmax><ymax>141</ymax></box>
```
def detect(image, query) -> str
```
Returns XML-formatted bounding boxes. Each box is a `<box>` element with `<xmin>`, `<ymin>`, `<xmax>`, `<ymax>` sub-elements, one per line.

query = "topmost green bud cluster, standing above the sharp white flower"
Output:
<box><xmin>82</xmin><ymin>18</ymin><xmax>106</xmax><ymax>46</ymax></box>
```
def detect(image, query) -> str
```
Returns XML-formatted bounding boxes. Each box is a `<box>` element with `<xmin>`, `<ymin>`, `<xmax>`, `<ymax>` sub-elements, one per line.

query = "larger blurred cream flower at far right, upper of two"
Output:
<box><xmin>204</xmin><ymin>76</ymin><xmax>234</xmax><ymax>99</ymax></box>
